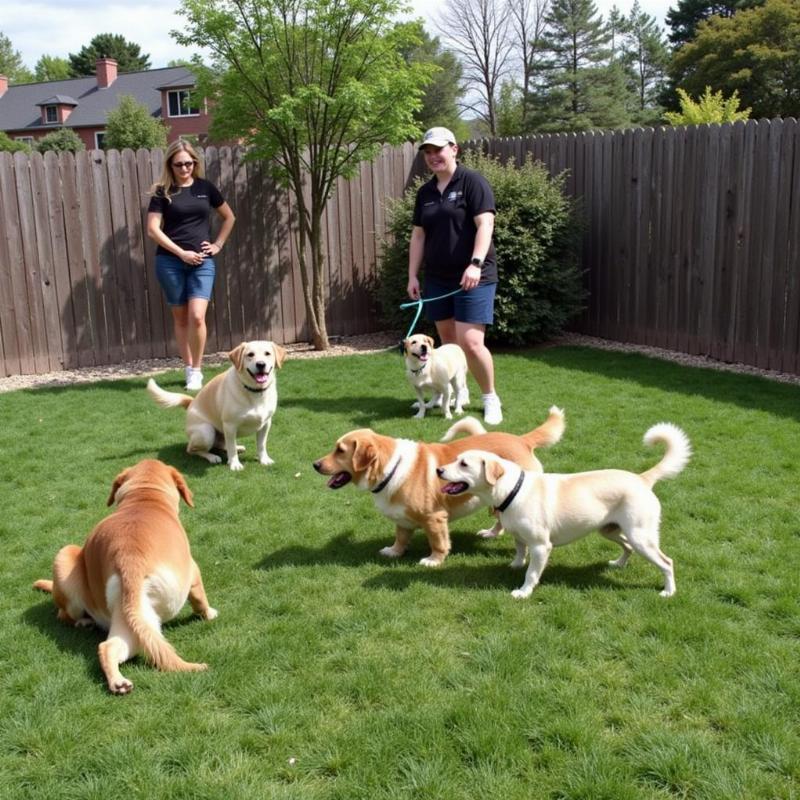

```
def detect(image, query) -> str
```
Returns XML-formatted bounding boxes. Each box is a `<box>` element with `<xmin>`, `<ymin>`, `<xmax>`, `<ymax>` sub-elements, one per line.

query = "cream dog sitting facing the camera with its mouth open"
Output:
<box><xmin>147</xmin><ymin>341</ymin><xmax>286</xmax><ymax>471</ymax></box>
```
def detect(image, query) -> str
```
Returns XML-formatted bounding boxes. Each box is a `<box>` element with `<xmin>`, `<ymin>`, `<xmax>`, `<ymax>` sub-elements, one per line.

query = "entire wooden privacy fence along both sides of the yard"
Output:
<box><xmin>0</xmin><ymin>119</ymin><xmax>800</xmax><ymax>374</ymax></box>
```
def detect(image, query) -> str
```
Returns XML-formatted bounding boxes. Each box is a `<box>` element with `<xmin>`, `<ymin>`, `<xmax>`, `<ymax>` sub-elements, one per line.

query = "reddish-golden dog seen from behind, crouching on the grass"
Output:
<box><xmin>33</xmin><ymin>460</ymin><xmax>217</xmax><ymax>694</ymax></box>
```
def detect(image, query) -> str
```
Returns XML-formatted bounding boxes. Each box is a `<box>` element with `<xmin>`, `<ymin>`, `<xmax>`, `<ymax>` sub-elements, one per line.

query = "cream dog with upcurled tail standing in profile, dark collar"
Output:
<box><xmin>437</xmin><ymin>422</ymin><xmax>692</xmax><ymax>598</ymax></box>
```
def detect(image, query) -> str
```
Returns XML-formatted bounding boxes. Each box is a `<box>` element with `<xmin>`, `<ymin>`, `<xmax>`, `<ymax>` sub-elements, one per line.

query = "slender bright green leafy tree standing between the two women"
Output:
<box><xmin>177</xmin><ymin>0</ymin><xmax>433</xmax><ymax>349</ymax></box>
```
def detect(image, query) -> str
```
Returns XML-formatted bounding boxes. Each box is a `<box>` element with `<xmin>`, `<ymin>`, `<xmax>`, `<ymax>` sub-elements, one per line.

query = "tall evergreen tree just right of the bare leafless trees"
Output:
<box><xmin>532</xmin><ymin>0</ymin><xmax>630</xmax><ymax>131</ymax></box>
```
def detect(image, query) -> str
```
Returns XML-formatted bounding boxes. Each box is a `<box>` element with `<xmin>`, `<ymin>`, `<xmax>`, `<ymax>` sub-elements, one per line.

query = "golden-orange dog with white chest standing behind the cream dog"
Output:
<box><xmin>314</xmin><ymin>407</ymin><xmax>564</xmax><ymax>567</ymax></box>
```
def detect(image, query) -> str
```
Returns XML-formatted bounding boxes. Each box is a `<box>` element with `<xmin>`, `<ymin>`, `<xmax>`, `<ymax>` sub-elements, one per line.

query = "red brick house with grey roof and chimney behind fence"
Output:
<box><xmin>0</xmin><ymin>58</ymin><xmax>210</xmax><ymax>150</ymax></box>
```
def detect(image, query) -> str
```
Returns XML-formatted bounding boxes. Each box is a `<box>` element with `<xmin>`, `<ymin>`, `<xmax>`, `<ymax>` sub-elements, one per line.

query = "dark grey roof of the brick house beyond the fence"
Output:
<box><xmin>0</xmin><ymin>67</ymin><xmax>195</xmax><ymax>131</ymax></box>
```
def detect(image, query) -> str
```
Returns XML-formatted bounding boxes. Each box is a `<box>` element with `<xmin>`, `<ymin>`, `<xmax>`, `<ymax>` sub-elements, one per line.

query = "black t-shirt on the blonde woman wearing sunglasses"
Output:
<box><xmin>147</xmin><ymin>178</ymin><xmax>225</xmax><ymax>255</ymax></box>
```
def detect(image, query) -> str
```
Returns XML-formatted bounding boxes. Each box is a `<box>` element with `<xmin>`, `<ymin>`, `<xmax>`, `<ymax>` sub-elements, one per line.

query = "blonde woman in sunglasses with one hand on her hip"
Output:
<box><xmin>147</xmin><ymin>139</ymin><xmax>236</xmax><ymax>391</ymax></box>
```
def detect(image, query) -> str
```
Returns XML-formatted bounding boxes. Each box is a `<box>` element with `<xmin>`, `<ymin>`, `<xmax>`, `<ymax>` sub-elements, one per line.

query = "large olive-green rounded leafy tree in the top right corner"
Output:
<box><xmin>670</xmin><ymin>0</ymin><xmax>800</xmax><ymax>118</ymax></box>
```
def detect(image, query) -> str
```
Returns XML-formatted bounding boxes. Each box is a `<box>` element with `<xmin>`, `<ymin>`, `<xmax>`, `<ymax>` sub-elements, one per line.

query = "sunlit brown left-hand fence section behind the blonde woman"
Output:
<box><xmin>0</xmin><ymin>144</ymin><xmax>415</xmax><ymax>375</ymax></box>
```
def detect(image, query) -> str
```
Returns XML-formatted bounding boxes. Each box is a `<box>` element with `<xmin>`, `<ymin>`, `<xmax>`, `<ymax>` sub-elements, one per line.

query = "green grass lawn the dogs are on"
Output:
<box><xmin>0</xmin><ymin>347</ymin><xmax>800</xmax><ymax>800</ymax></box>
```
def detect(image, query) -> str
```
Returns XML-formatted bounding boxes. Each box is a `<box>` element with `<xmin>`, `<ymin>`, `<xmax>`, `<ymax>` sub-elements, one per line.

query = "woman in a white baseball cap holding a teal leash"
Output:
<box><xmin>407</xmin><ymin>128</ymin><xmax>503</xmax><ymax>425</ymax></box>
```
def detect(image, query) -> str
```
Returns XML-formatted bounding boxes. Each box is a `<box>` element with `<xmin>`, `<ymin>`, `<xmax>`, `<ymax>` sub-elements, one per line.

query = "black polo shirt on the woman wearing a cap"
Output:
<box><xmin>413</xmin><ymin>164</ymin><xmax>497</xmax><ymax>284</ymax></box>
